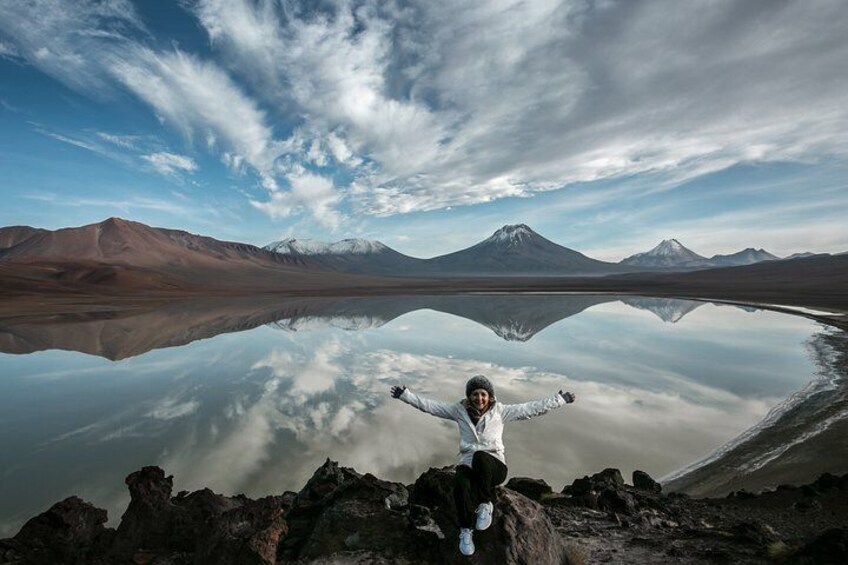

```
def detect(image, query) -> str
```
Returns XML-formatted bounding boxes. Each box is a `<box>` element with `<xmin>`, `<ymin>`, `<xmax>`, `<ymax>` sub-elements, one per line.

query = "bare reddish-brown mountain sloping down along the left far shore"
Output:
<box><xmin>0</xmin><ymin>218</ymin><xmax>380</xmax><ymax>291</ymax></box>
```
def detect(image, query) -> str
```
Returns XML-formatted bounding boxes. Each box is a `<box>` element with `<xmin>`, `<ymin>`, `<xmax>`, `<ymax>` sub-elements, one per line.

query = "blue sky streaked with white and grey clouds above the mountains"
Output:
<box><xmin>0</xmin><ymin>0</ymin><xmax>848</xmax><ymax>261</ymax></box>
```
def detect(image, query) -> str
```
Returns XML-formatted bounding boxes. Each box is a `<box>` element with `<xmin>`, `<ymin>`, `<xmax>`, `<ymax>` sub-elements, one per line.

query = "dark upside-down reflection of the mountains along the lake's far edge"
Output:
<box><xmin>0</xmin><ymin>294</ymin><xmax>703</xmax><ymax>361</ymax></box>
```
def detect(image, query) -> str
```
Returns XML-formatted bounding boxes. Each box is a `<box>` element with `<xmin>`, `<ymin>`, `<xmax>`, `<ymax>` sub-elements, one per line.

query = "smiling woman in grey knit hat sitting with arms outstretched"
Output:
<box><xmin>391</xmin><ymin>375</ymin><xmax>575</xmax><ymax>555</ymax></box>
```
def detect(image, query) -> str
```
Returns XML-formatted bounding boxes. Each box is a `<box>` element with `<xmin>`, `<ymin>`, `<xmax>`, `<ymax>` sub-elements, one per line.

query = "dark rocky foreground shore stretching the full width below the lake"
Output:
<box><xmin>0</xmin><ymin>459</ymin><xmax>848</xmax><ymax>565</ymax></box>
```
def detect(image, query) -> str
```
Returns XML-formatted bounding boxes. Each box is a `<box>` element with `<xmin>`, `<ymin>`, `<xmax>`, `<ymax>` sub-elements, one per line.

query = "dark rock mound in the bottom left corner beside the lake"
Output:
<box><xmin>4</xmin><ymin>496</ymin><xmax>115</xmax><ymax>564</ymax></box>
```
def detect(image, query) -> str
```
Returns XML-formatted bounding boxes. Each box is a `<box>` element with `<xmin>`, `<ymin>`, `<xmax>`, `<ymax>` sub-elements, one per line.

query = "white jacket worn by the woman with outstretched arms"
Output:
<box><xmin>400</xmin><ymin>389</ymin><xmax>566</xmax><ymax>467</ymax></box>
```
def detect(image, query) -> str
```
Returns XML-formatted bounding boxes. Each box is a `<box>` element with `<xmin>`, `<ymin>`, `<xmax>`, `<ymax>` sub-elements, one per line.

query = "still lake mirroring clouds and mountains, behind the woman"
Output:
<box><xmin>0</xmin><ymin>295</ymin><xmax>832</xmax><ymax>537</ymax></box>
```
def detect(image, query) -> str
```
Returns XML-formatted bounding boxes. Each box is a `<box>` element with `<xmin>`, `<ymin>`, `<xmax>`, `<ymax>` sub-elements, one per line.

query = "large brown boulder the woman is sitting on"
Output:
<box><xmin>410</xmin><ymin>467</ymin><xmax>566</xmax><ymax>565</ymax></box>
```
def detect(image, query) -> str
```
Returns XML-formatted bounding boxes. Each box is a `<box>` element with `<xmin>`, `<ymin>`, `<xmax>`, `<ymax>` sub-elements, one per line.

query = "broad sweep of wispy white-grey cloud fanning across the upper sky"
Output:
<box><xmin>0</xmin><ymin>0</ymin><xmax>848</xmax><ymax>226</ymax></box>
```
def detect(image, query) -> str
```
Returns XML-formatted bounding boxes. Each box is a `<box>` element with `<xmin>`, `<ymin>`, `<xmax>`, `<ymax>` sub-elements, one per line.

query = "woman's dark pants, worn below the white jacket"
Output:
<box><xmin>453</xmin><ymin>451</ymin><xmax>506</xmax><ymax>529</ymax></box>
